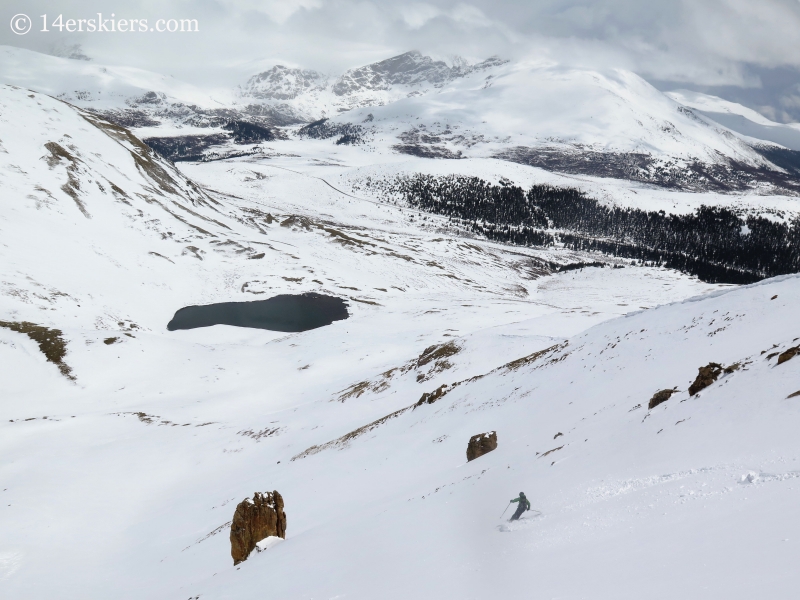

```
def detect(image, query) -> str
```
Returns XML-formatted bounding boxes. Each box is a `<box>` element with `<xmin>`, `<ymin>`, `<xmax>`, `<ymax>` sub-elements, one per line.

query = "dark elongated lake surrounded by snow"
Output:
<box><xmin>167</xmin><ymin>293</ymin><xmax>350</xmax><ymax>332</ymax></box>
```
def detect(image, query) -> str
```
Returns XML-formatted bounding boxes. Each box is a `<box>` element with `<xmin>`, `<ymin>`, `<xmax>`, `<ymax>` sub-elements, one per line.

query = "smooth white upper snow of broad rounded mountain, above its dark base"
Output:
<box><xmin>326</xmin><ymin>62</ymin><xmax>763</xmax><ymax>164</ymax></box>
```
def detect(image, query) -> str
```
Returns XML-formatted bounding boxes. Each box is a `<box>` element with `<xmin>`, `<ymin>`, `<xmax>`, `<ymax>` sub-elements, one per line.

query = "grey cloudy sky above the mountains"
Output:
<box><xmin>0</xmin><ymin>0</ymin><xmax>800</xmax><ymax>121</ymax></box>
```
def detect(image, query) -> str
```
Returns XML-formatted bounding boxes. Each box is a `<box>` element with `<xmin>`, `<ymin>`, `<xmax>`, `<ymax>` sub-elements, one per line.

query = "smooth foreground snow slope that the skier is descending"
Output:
<box><xmin>191</xmin><ymin>277</ymin><xmax>800</xmax><ymax>599</ymax></box>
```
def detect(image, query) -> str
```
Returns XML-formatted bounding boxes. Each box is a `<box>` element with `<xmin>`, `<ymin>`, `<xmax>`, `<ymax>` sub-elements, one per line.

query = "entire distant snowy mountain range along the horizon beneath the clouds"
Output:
<box><xmin>6</xmin><ymin>47</ymin><xmax>800</xmax><ymax>193</ymax></box>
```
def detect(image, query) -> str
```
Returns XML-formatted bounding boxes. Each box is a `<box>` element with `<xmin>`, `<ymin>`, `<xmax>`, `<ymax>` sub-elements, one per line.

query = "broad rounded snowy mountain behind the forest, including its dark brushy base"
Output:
<box><xmin>318</xmin><ymin>63</ymin><xmax>780</xmax><ymax>183</ymax></box>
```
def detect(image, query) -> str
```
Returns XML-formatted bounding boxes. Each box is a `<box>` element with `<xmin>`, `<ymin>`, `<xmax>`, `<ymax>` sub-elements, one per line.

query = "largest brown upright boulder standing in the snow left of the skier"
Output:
<box><xmin>231</xmin><ymin>491</ymin><xmax>286</xmax><ymax>565</ymax></box>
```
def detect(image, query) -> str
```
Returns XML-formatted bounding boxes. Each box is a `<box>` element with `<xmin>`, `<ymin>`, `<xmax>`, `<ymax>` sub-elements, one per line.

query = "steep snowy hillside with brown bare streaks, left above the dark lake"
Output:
<box><xmin>0</xmin><ymin>86</ymin><xmax>248</xmax><ymax>338</ymax></box>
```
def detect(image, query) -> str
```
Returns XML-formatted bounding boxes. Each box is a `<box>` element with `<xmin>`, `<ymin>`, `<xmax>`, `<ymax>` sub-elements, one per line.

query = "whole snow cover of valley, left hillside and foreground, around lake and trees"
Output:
<box><xmin>0</xmin><ymin>67</ymin><xmax>800</xmax><ymax>600</ymax></box>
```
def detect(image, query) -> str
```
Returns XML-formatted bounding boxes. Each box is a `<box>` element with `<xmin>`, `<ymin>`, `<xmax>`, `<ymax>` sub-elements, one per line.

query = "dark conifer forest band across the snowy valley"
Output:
<box><xmin>384</xmin><ymin>174</ymin><xmax>800</xmax><ymax>284</ymax></box>
